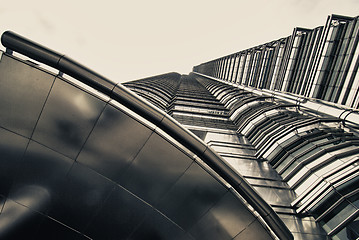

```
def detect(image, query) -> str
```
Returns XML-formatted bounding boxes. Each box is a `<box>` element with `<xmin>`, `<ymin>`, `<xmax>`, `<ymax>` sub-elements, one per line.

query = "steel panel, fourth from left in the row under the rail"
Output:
<box><xmin>120</xmin><ymin>132</ymin><xmax>192</xmax><ymax>204</ymax></box>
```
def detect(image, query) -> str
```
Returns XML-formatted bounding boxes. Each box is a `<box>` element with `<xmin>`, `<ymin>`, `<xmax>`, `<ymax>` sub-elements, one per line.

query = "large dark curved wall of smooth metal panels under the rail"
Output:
<box><xmin>0</xmin><ymin>47</ymin><xmax>284</xmax><ymax>239</ymax></box>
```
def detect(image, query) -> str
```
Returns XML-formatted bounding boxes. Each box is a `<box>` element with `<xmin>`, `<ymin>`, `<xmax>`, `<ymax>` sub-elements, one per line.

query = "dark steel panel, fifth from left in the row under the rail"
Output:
<box><xmin>158</xmin><ymin>162</ymin><xmax>227</xmax><ymax>230</ymax></box>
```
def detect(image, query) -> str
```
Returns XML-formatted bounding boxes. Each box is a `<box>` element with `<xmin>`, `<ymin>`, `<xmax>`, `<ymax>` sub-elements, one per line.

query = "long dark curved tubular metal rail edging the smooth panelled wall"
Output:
<box><xmin>1</xmin><ymin>31</ymin><xmax>293</xmax><ymax>239</ymax></box>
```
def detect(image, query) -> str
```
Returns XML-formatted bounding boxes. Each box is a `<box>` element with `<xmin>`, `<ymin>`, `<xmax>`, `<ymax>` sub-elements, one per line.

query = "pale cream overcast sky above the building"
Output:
<box><xmin>0</xmin><ymin>0</ymin><xmax>359</xmax><ymax>82</ymax></box>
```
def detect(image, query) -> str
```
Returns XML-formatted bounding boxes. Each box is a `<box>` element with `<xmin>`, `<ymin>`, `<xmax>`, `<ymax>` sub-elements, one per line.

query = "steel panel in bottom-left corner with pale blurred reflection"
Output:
<box><xmin>0</xmin><ymin>199</ymin><xmax>43</xmax><ymax>240</ymax></box>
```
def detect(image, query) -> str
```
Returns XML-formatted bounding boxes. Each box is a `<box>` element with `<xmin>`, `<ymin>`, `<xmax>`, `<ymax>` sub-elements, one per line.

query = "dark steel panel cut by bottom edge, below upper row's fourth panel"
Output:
<box><xmin>84</xmin><ymin>186</ymin><xmax>152</xmax><ymax>239</ymax></box>
